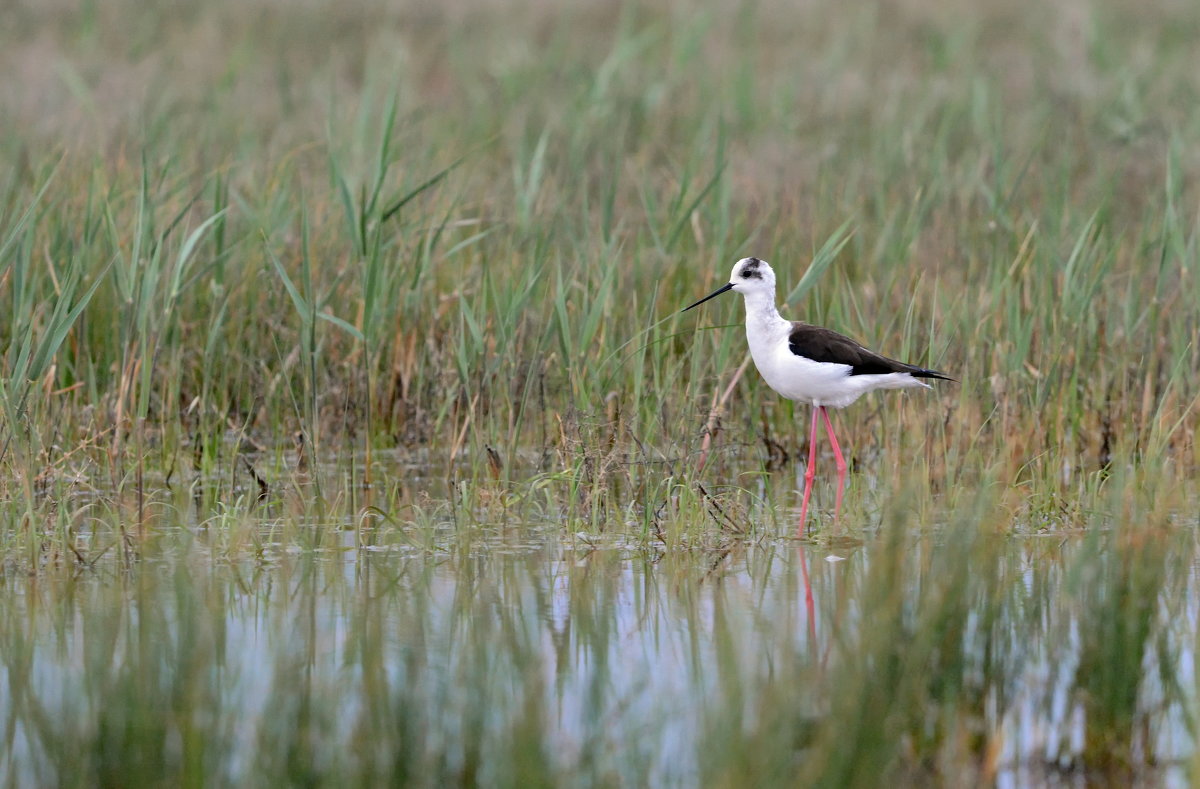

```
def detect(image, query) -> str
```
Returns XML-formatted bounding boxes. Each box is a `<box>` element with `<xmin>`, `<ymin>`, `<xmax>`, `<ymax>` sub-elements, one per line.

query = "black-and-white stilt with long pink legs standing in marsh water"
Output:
<box><xmin>683</xmin><ymin>258</ymin><xmax>954</xmax><ymax>537</ymax></box>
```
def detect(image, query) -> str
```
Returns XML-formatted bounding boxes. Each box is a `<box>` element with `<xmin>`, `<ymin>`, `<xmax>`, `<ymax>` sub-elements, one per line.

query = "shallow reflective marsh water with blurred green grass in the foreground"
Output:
<box><xmin>0</xmin><ymin>522</ymin><xmax>1198</xmax><ymax>787</ymax></box>
